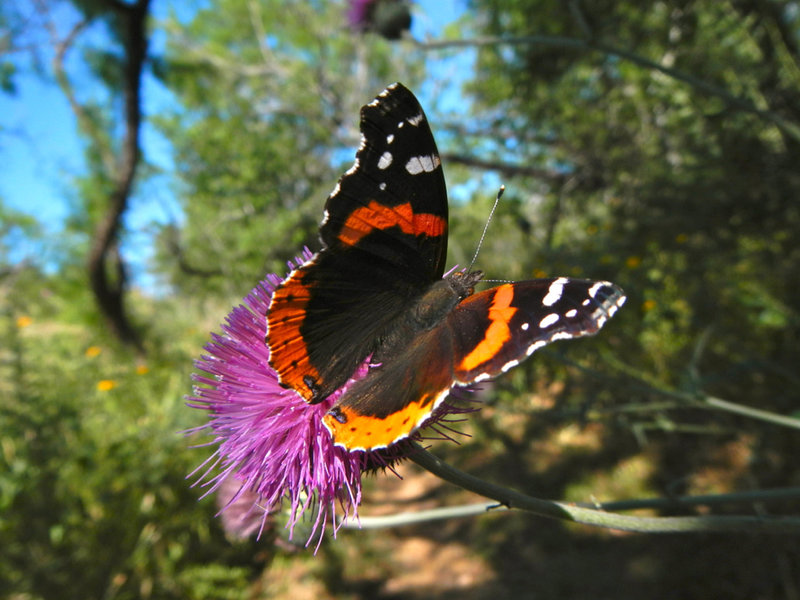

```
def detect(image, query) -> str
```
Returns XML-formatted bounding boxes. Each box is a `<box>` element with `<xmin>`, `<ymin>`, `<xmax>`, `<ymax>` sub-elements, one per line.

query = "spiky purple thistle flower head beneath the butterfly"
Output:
<box><xmin>188</xmin><ymin>250</ymin><xmax>474</xmax><ymax>542</ymax></box>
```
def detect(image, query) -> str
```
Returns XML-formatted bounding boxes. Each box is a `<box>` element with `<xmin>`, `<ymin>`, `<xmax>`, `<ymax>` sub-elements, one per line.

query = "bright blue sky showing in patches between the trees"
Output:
<box><xmin>0</xmin><ymin>0</ymin><xmax>469</xmax><ymax>287</ymax></box>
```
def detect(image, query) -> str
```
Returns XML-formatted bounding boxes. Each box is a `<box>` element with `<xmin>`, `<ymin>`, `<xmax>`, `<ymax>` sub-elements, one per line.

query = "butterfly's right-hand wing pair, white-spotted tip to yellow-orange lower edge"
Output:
<box><xmin>324</xmin><ymin>277</ymin><xmax>625</xmax><ymax>450</ymax></box>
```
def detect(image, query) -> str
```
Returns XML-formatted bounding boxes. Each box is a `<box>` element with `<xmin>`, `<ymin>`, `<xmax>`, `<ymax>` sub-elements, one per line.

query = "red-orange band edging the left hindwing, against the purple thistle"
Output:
<box><xmin>267</xmin><ymin>271</ymin><xmax>319</xmax><ymax>400</ymax></box>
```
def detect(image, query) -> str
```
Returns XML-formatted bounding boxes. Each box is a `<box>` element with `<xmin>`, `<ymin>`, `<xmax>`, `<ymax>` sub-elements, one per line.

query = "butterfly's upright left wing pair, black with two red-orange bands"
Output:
<box><xmin>267</xmin><ymin>84</ymin><xmax>447</xmax><ymax>402</ymax></box>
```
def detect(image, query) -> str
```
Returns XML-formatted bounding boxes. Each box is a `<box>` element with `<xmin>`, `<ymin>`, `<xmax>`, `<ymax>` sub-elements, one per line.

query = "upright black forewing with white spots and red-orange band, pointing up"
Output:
<box><xmin>320</xmin><ymin>84</ymin><xmax>447</xmax><ymax>283</ymax></box>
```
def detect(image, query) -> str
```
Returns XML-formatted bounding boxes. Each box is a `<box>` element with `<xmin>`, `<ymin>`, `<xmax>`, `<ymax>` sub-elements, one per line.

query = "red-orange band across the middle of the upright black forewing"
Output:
<box><xmin>338</xmin><ymin>200</ymin><xmax>447</xmax><ymax>246</ymax></box>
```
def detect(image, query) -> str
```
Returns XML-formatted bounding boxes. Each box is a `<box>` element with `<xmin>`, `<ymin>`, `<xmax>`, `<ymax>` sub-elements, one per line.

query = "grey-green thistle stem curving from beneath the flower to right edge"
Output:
<box><xmin>370</xmin><ymin>445</ymin><xmax>800</xmax><ymax>535</ymax></box>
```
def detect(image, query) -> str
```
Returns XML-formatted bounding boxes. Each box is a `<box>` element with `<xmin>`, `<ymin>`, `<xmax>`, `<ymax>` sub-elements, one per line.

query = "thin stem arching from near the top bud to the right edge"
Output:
<box><xmin>415</xmin><ymin>35</ymin><xmax>800</xmax><ymax>142</ymax></box>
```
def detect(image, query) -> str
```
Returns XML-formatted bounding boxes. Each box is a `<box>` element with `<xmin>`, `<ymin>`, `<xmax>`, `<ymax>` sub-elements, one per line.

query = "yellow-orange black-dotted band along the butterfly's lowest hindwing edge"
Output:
<box><xmin>323</xmin><ymin>394</ymin><xmax>436</xmax><ymax>450</ymax></box>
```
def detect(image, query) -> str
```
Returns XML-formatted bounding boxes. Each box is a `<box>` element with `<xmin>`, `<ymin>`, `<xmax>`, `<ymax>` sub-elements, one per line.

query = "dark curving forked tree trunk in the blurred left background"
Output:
<box><xmin>48</xmin><ymin>0</ymin><xmax>149</xmax><ymax>354</ymax></box>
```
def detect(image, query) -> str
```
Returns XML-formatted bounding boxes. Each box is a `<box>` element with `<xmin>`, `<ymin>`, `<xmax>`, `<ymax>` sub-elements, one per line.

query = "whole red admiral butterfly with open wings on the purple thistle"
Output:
<box><xmin>266</xmin><ymin>83</ymin><xmax>625</xmax><ymax>450</ymax></box>
